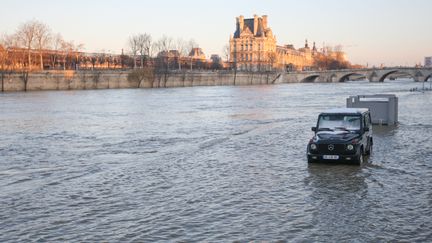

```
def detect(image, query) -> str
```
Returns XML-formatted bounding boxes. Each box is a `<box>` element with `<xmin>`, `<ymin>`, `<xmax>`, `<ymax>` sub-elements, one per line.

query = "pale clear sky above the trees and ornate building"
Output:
<box><xmin>0</xmin><ymin>0</ymin><xmax>432</xmax><ymax>66</ymax></box>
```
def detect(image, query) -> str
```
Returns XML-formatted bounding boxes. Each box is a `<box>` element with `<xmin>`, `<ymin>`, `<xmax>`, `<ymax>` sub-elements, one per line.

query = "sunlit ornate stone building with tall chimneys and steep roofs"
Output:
<box><xmin>230</xmin><ymin>15</ymin><xmax>318</xmax><ymax>71</ymax></box>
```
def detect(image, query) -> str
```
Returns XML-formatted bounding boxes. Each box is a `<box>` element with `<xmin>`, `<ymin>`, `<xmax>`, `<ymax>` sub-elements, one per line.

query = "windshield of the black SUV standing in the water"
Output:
<box><xmin>318</xmin><ymin>114</ymin><xmax>361</xmax><ymax>131</ymax></box>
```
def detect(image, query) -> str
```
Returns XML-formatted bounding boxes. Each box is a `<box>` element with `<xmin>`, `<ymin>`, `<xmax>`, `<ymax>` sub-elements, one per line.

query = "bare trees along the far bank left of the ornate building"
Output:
<box><xmin>0</xmin><ymin>20</ymin><xmax>226</xmax><ymax>71</ymax></box>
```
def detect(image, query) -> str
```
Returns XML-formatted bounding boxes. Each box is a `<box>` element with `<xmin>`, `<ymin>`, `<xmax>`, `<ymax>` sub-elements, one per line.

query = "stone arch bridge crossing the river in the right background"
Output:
<box><xmin>279</xmin><ymin>67</ymin><xmax>432</xmax><ymax>83</ymax></box>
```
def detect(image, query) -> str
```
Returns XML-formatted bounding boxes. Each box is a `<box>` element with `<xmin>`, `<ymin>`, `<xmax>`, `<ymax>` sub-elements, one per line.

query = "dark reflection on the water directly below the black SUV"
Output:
<box><xmin>305</xmin><ymin>164</ymin><xmax>370</xmax><ymax>241</ymax></box>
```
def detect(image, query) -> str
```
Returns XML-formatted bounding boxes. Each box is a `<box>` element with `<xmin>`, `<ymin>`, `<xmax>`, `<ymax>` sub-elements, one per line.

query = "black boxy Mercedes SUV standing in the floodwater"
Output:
<box><xmin>307</xmin><ymin>108</ymin><xmax>373</xmax><ymax>164</ymax></box>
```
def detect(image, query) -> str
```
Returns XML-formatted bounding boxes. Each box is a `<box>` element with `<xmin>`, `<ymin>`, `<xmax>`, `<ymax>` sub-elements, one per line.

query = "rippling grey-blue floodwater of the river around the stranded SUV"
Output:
<box><xmin>0</xmin><ymin>81</ymin><xmax>432</xmax><ymax>242</ymax></box>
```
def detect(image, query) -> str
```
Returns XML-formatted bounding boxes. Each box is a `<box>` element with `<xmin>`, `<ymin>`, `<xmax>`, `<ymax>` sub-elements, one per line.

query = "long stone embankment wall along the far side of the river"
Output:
<box><xmin>1</xmin><ymin>69</ymin><xmax>281</xmax><ymax>92</ymax></box>
